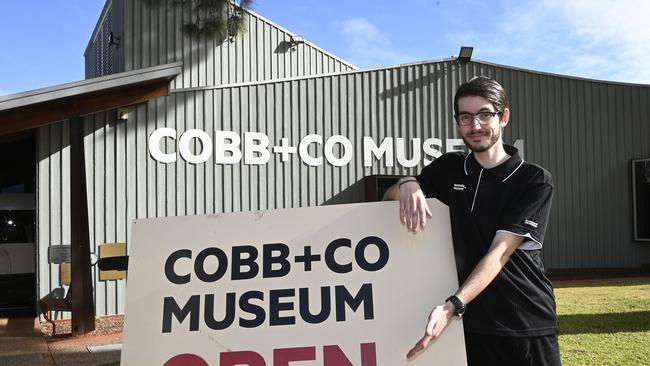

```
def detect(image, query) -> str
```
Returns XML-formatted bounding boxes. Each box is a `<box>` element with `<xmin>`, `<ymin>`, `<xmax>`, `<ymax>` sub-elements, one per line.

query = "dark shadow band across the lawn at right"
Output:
<box><xmin>557</xmin><ymin>311</ymin><xmax>650</xmax><ymax>334</ymax></box>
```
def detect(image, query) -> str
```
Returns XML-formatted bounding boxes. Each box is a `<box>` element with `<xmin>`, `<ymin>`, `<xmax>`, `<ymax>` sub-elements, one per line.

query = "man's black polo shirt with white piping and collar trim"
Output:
<box><xmin>417</xmin><ymin>145</ymin><xmax>558</xmax><ymax>336</ymax></box>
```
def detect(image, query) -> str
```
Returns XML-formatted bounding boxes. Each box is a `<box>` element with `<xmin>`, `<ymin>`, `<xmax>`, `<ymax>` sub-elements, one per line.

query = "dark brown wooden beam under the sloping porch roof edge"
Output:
<box><xmin>0</xmin><ymin>79</ymin><xmax>169</xmax><ymax>135</ymax></box>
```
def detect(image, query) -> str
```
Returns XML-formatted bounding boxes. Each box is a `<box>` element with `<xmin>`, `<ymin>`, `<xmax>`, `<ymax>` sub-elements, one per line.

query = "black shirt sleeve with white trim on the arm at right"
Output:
<box><xmin>497</xmin><ymin>182</ymin><xmax>553</xmax><ymax>249</ymax></box>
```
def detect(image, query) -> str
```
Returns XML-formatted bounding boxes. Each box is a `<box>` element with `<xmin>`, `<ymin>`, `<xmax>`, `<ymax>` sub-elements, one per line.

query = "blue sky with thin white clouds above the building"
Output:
<box><xmin>0</xmin><ymin>0</ymin><xmax>650</xmax><ymax>95</ymax></box>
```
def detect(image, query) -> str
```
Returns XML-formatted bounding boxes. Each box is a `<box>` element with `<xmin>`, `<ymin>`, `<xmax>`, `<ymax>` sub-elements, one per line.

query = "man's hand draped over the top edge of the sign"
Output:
<box><xmin>398</xmin><ymin>178</ymin><xmax>431</xmax><ymax>233</ymax></box>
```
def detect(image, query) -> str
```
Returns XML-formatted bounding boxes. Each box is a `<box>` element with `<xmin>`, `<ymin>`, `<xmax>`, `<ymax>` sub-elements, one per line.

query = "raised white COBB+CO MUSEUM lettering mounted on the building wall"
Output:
<box><xmin>148</xmin><ymin>127</ymin><xmax>524</xmax><ymax>168</ymax></box>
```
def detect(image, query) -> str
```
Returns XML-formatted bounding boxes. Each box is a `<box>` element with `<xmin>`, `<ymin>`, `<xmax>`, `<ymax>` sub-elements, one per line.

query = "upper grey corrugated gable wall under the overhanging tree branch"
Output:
<box><xmin>124</xmin><ymin>0</ymin><xmax>355</xmax><ymax>88</ymax></box>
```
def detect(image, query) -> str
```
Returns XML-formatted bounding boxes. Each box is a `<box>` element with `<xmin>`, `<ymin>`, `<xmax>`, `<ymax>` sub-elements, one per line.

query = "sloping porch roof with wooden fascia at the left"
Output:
<box><xmin>0</xmin><ymin>62</ymin><xmax>181</xmax><ymax>136</ymax></box>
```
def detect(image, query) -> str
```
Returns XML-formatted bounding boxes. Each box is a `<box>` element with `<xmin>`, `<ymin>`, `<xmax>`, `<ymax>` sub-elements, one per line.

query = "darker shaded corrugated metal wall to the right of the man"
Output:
<box><xmin>468</xmin><ymin>63</ymin><xmax>650</xmax><ymax>268</ymax></box>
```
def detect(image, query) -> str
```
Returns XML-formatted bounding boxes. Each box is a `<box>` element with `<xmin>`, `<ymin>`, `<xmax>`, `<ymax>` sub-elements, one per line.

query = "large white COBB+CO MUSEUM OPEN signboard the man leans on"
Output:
<box><xmin>121</xmin><ymin>200</ymin><xmax>466</xmax><ymax>366</ymax></box>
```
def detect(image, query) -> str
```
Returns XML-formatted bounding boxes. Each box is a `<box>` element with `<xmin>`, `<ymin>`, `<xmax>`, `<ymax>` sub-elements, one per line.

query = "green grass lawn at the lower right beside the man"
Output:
<box><xmin>553</xmin><ymin>277</ymin><xmax>650</xmax><ymax>366</ymax></box>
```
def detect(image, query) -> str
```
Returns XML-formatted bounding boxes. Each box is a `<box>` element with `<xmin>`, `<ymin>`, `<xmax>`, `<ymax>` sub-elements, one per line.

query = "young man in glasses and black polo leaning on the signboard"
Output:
<box><xmin>386</xmin><ymin>77</ymin><xmax>561</xmax><ymax>365</ymax></box>
